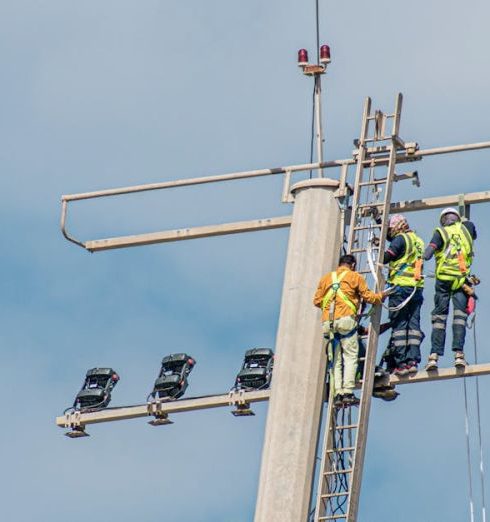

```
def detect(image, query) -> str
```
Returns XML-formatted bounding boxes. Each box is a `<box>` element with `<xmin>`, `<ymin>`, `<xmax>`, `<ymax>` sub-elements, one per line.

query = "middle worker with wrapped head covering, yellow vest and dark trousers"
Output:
<box><xmin>383</xmin><ymin>214</ymin><xmax>424</xmax><ymax>376</ymax></box>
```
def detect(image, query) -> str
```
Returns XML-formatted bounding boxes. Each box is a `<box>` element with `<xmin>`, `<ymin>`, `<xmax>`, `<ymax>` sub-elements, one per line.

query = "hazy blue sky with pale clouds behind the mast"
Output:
<box><xmin>0</xmin><ymin>0</ymin><xmax>490</xmax><ymax>522</ymax></box>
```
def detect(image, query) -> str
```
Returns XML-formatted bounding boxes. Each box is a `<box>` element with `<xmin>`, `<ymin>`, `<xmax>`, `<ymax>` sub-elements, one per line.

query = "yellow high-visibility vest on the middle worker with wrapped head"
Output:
<box><xmin>388</xmin><ymin>232</ymin><xmax>424</xmax><ymax>288</ymax></box>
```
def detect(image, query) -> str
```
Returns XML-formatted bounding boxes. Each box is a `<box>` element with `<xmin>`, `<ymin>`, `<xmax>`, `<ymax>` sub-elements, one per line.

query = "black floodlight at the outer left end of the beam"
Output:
<box><xmin>73</xmin><ymin>368</ymin><xmax>119</xmax><ymax>411</ymax></box>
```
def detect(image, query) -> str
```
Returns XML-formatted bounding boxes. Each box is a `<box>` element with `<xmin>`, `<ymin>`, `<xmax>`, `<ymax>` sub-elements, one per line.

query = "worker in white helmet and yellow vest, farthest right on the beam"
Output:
<box><xmin>424</xmin><ymin>207</ymin><xmax>476</xmax><ymax>370</ymax></box>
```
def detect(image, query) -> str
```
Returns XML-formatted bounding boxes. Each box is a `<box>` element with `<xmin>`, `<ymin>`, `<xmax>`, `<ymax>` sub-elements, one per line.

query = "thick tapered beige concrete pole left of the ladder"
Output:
<box><xmin>255</xmin><ymin>178</ymin><xmax>340</xmax><ymax>522</ymax></box>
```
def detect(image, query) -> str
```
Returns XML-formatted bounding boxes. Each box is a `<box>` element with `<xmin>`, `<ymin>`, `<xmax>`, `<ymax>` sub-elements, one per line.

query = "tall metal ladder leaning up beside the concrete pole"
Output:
<box><xmin>314</xmin><ymin>94</ymin><xmax>405</xmax><ymax>522</ymax></box>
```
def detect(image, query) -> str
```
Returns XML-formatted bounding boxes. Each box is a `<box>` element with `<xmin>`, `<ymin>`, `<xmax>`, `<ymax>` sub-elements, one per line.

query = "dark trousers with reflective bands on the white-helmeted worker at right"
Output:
<box><xmin>431</xmin><ymin>279</ymin><xmax>468</xmax><ymax>355</ymax></box>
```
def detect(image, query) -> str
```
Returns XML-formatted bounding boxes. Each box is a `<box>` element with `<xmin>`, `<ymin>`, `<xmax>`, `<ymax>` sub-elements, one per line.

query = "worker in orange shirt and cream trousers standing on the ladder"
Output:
<box><xmin>313</xmin><ymin>254</ymin><xmax>384</xmax><ymax>407</ymax></box>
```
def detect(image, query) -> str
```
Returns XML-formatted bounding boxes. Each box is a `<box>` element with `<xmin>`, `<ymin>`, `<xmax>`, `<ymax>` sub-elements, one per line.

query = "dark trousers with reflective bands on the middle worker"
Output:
<box><xmin>389</xmin><ymin>286</ymin><xmax>424</xmax><ymax>368</ymax></box>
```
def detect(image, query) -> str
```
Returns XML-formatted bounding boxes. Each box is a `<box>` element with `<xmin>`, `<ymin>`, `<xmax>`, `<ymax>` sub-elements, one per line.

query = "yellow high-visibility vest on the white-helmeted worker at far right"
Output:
<box><xmin>436</xmin><ymin>222</ymin><xmax>473</xmax><ymax>290</ymax></box>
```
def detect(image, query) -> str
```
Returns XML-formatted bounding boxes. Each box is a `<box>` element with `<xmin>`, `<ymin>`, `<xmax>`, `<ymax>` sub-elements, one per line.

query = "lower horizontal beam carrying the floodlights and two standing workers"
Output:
<box><xmin>56</xmin><ymin>363</ymin><xmax>490</xmax><ymax>428</ymax></box>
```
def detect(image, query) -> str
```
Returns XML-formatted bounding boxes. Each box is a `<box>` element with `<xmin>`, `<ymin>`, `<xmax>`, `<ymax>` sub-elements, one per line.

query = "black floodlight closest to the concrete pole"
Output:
<box><xmin>234</xmin><ymin>348</ymin><xmax>274</xmax><ymax>391</ymax></box>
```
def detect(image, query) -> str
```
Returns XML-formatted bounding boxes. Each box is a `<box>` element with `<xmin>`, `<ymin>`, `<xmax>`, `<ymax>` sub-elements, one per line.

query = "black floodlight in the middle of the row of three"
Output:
<box><xmin>147</xmin><ymin>353</ymin><xmax>196</xmax><ymax>401</ymax></box>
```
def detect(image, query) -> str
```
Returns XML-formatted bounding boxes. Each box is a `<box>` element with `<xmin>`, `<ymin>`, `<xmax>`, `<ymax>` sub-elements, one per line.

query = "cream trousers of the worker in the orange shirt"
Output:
<box><xmin>323</xmin><ymin>316</ymin><xmax>359</xmax><ymax>395</ymax></box>
